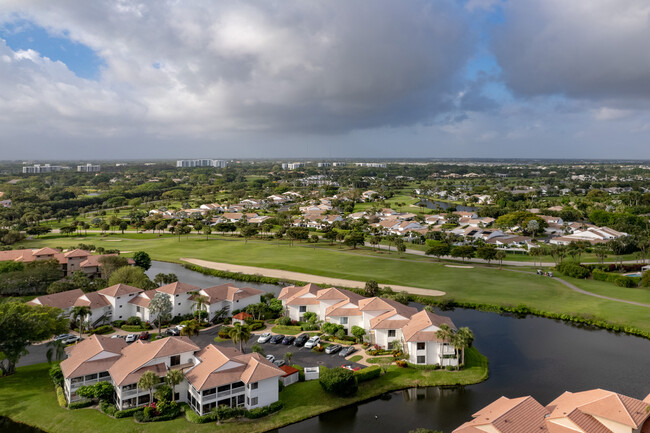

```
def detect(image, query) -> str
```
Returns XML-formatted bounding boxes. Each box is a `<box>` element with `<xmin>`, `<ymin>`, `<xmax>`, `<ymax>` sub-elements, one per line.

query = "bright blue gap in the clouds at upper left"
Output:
<box><xmin>0</xmin><ymin>20</ymin><xmax>105</xmax><ymax>80</ymax></box>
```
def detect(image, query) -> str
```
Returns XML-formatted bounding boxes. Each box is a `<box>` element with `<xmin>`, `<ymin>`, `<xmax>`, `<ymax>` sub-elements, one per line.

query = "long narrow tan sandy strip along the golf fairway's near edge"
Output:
<box><xmin>180</xmin><ymin>257</ymin><xmax>445</xmax><ymax>296</ymax></box>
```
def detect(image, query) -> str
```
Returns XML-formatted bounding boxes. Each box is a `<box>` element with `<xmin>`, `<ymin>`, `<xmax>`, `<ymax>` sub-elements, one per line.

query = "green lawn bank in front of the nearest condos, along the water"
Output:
<box><xmin>0</xmin><ymin>349</ymin><xmax>488</xmax><ymax>433</ymax></box>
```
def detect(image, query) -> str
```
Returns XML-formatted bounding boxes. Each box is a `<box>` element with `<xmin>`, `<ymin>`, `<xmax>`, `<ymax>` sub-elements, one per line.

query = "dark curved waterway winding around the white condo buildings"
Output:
<box><xmin>156</xmin><ymin>262</ymin><xmax>650</xmax><ymax>433</ymax></box>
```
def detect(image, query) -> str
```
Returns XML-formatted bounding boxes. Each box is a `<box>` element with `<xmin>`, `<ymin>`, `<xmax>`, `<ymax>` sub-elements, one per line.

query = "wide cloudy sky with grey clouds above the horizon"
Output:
<box><xmin>0</xmin><ymin>0</ymin><xmax>650</xmax><ymax>160</ymax></box>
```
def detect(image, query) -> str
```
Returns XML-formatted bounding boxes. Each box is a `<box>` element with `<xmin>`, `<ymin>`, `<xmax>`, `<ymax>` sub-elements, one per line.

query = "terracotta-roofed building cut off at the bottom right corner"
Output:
<box><xmin>453</xmin><ymin>389</ymin><xmax>650</xmax><ymax>433</ymax></box>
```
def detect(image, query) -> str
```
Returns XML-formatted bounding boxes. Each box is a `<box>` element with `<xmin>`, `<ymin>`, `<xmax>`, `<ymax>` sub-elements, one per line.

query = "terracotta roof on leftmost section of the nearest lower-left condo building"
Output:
<box><xmin>61</xmin><ymin>335</ymin><xmax>126</xmax><ymax>378</ymax></box>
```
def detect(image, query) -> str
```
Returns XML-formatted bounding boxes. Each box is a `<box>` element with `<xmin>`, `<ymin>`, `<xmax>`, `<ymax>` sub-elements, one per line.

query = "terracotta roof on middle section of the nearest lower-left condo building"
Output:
<box><xmin>109</xmin><ymin>337</ymin><xmax>199</xmax><ymax>386</ymax></box>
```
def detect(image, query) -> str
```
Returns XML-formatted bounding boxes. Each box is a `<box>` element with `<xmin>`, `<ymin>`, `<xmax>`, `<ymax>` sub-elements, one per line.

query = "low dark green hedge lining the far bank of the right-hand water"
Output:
<box><xmin>409</xmin><ymin>296</ymin><xmax>650</xmax><ymax>339</ymax></box>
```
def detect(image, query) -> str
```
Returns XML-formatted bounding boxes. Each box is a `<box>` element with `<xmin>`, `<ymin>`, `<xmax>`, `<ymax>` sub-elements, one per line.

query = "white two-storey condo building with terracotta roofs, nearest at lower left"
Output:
<box><xmin>61</xmin><ymin>335</ymin><xmax>286</xmax><ymax>415</ymax></box>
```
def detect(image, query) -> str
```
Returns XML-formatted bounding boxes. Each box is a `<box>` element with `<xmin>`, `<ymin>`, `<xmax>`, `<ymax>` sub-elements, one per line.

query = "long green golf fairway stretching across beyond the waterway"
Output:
<box><xmin>21</xmin><ymin>235</ymin><xmax>650</xmax><ymax>331</ymax></box>
